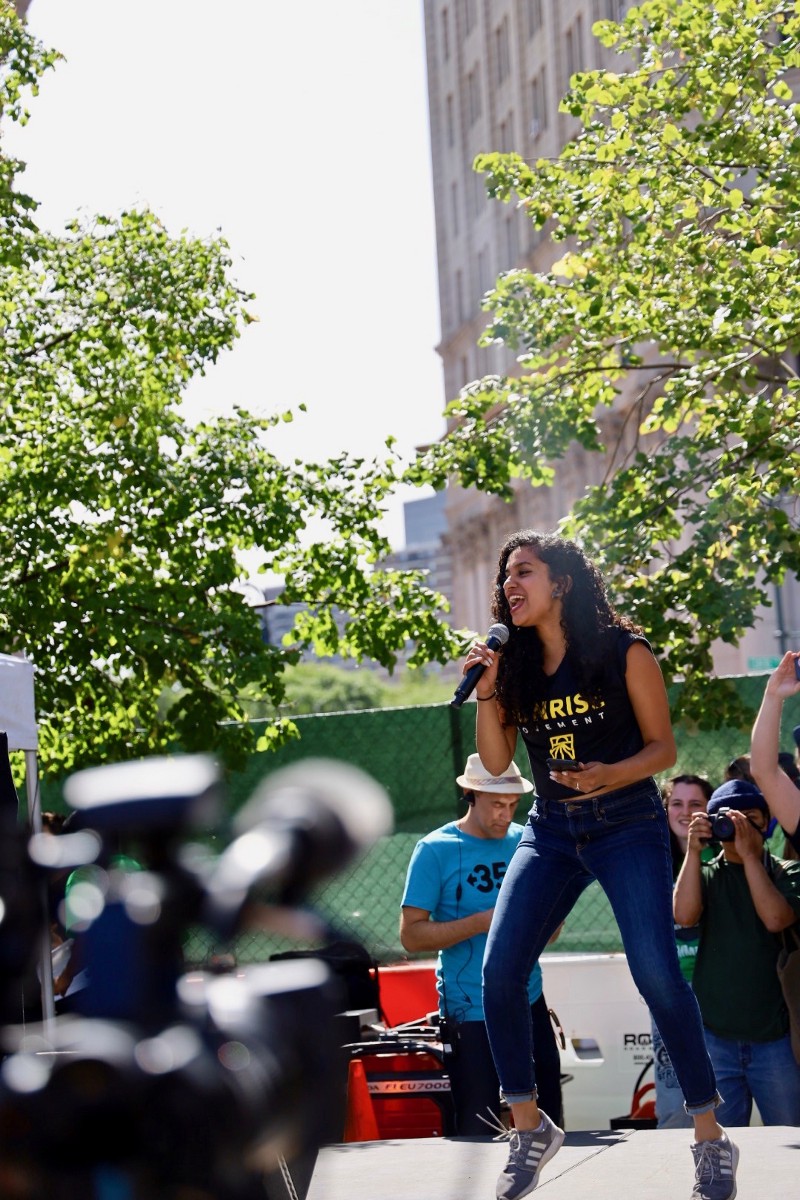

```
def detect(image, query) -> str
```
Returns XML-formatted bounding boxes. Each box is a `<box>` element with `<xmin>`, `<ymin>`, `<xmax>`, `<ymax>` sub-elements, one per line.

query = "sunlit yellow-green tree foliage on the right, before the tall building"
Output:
<box><xmin>411</xmin><ymin>0</ymin><xmax>800</xmax><ymax>720</ymax></box>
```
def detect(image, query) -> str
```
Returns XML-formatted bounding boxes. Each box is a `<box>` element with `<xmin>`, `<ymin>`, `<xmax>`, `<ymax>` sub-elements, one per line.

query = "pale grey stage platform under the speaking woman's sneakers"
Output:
<box><xmin>307</xmin><ymin>1126</ymin><xmax>800</xmax><ymax>1200</ymax></box>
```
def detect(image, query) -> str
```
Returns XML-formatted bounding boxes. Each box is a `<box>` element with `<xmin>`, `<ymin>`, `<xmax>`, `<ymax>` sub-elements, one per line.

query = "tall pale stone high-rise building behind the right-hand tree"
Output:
<box><xmin>425</xmin><ymin>0</ymin><xmax>800</xmax><ymax>674</ymax></box>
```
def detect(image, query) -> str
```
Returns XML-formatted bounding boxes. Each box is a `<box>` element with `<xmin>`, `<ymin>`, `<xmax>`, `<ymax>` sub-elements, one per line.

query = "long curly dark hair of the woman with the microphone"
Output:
<box><xmin>492</xmin><ymin>529</ymin><xmax>642</xmax><ymax>725</ymax></box>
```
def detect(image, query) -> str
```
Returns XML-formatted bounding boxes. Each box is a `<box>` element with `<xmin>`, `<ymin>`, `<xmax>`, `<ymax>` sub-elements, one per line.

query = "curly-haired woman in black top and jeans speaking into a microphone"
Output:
<box><xmin>464</xmin><ymin>529</ymin><xmax>738</xmax><ymax>1200</ymax></box>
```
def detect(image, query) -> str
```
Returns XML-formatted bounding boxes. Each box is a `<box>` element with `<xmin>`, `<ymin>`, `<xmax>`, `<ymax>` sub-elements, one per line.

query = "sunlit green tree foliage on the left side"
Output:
<box><xmin>0</xmin><ymin>7</ymin><xmax>459</xmax><ymax>774</ymax></box>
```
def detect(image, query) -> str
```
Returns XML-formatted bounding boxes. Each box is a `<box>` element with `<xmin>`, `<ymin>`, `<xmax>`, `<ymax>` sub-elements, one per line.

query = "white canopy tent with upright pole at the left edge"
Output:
<box><xmin>0</xmin><ymin>654</ymin><xmax>55</xmax><ymax>1020</ymax></box>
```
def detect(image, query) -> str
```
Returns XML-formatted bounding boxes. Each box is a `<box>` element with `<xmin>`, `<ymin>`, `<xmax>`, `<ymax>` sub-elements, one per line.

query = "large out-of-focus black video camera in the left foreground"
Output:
<box><xmin>0</xmin><ymin>756</ymin><xmax>391</xmax><ymax>1200</ymax></box>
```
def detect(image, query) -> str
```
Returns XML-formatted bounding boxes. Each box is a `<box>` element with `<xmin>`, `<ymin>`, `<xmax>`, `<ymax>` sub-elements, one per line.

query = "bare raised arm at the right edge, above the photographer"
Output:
<box><xmin>750</xmin><ymin>650</ymin><xmax>800</xmax><ymax>854</ymax></box>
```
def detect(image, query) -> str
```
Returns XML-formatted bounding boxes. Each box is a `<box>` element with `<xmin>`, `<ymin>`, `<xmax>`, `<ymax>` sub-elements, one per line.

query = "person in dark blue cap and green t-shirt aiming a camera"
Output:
<box><xmin>673</xmin><ymin>779</ymin><xmax>800</xmax><ymax>1126</ymax></box>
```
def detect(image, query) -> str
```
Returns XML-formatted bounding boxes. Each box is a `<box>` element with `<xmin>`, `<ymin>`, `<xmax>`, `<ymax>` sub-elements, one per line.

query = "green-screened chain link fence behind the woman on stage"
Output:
<box><xmin>181</xmin><ymin>676</ymin><xmax>800</xmax><ymax>965</ymax></box>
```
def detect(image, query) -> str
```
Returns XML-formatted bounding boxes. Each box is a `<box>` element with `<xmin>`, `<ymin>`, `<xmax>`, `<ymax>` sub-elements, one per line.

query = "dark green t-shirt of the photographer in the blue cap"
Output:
<box><xmin>692</xmin><ymin>854</ymin><xmax>800</xmax><ymax>1042</ymax></box>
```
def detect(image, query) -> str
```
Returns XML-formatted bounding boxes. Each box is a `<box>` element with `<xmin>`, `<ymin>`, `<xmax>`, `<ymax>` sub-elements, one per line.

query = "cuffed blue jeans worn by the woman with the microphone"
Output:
<box><xmin>483</xmin><ymin>779</ymin><xmax>720</xmax><ymax>1115</ymax></box>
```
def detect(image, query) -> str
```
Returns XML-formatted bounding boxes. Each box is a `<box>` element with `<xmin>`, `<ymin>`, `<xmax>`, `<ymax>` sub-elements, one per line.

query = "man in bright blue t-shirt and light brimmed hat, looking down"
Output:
<box><xmin>401</xmin><ymin>754</ymin><xmax>561</xmax><ymax>1136</ymax></box>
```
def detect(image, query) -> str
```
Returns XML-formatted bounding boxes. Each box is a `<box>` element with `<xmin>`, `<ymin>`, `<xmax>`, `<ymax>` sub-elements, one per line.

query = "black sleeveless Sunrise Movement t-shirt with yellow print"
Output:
<box><xmin>519</xmin><ymin>626</ymin><xmax>650</xmax><ymax>800</ymax></box>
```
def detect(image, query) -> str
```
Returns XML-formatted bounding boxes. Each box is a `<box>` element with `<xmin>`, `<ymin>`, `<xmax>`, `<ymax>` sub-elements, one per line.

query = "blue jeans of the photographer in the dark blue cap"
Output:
<box><xmin>705</xmin><ymin>1028</ymin><xmax>800</xmax><ymax>1126</ymax></box>
